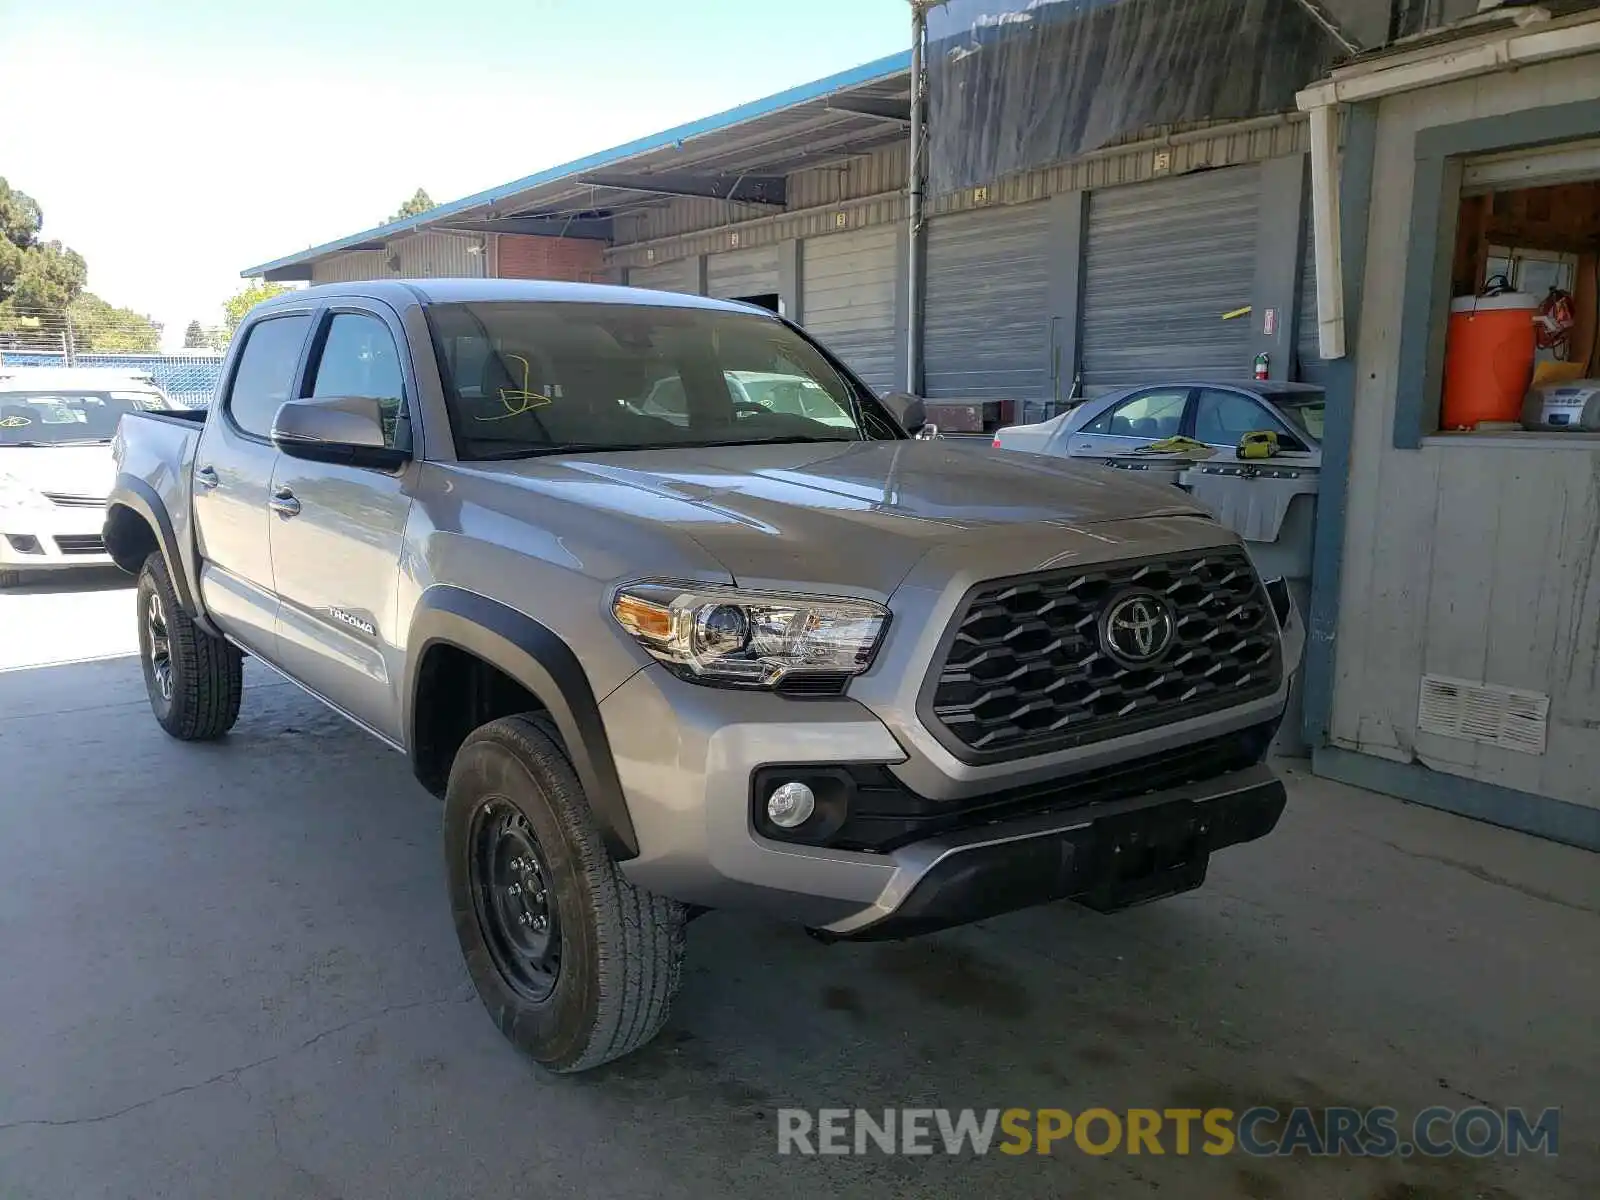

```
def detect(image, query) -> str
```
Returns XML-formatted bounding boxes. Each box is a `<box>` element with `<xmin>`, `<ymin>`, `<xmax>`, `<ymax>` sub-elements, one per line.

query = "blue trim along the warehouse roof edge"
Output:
<box><xmin>238</xmin><ymin>50</ymin><xmax>910</xmax><ymax>278</ymax></box>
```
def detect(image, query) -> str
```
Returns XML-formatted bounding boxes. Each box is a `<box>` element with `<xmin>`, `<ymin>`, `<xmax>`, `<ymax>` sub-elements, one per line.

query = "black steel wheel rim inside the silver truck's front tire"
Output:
<box><xmin>470</xmin><ymin>797</ymin><xmax>562</xmax><ymax>1003</ymax></box>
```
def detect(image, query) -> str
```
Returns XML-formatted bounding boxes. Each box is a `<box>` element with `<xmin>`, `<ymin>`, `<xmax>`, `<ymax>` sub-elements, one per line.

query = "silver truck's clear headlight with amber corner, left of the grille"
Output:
<box><xmin>611</xmin><ymin>581</ymin><xmax>890</xmax><ymax>688</ymax></box>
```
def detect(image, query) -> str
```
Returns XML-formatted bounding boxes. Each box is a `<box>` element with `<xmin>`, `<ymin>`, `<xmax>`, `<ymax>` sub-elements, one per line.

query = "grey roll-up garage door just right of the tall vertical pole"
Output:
<box><xmin>923</xmin><ymin>203</ymin><xmax>1053</xmax><ymax>400</ymax></box>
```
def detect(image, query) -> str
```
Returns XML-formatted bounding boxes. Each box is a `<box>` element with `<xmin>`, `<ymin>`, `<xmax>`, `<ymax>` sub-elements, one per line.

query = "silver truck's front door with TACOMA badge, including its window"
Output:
<box><xmin>270</xmin><ymin>304</ymin><xmax>416</xmax><ymax>742</ymax></box>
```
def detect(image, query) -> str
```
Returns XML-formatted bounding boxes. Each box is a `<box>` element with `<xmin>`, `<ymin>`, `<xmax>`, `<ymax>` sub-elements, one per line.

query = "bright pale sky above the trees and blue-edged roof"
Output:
<box><xmin>0</xmin><ymin>0</ymin><xmax>910</xmax><ymax>349</ymax></box>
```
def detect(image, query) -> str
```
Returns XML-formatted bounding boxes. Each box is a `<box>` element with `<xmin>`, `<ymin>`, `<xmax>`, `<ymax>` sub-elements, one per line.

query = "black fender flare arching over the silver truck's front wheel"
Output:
<box><xmin>403</xmin><ymin>584</ymin><xmax>638</xmax><ymax>861</ymax></box>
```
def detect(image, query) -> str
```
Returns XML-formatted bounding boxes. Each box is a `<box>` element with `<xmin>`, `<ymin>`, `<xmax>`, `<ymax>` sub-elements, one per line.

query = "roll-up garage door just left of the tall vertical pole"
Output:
<box><xmin>800</xmin><ymin>226</ymin><xmax>901</xmax><ymax>392</ymax></box>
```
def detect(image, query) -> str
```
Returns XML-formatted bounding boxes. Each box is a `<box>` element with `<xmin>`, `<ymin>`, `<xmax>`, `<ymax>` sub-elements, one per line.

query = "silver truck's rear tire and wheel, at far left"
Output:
<box><xmin>136</xmin><ymin>550</ymin><xmax>245</xmax><ymax>742</ymax></box>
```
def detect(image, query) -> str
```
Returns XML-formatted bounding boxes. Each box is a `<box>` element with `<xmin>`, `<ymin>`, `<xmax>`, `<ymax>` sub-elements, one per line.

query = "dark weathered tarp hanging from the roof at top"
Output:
<box><xmin>928</xmin><ymin>0</ymin><xmax>1339</xmax><ymax>192</ymax></box>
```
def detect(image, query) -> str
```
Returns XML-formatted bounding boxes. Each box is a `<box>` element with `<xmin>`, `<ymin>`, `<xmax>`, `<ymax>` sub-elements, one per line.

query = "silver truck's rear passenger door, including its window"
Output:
<box><xmin>194</xmin><ymin>307</ymin><xmax>312</xmax><ymax>661</ymax></box>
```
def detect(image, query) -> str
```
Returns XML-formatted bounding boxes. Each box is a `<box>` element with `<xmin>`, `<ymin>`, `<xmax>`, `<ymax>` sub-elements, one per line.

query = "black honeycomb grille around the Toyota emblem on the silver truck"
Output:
<box><xmin>922</xmin><ymin>547</ymin><xmax>1283</xmax><ymax>762</ymax></box>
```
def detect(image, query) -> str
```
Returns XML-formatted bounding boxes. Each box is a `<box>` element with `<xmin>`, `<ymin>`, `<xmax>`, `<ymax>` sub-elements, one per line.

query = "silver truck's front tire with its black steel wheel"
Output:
<box><xmin>445</xmin><ymin>717</ymin><xmax>685</xmax><ymax>1072</ymax></box>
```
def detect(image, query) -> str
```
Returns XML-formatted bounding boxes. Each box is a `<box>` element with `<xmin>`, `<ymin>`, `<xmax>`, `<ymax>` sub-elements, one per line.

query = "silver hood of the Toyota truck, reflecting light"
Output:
<box><xmin>475</xmin><ymin>442</ymin><xmax>1208</xmax><ymax>597</ymax></box>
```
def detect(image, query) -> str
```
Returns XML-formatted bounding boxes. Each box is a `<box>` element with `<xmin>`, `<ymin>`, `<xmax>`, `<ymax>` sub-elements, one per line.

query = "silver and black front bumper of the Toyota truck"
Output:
<box><xmin>600</xmin><ymin>572</ymin><xmax>1304</xmax><ymax>939</ymax></box>
